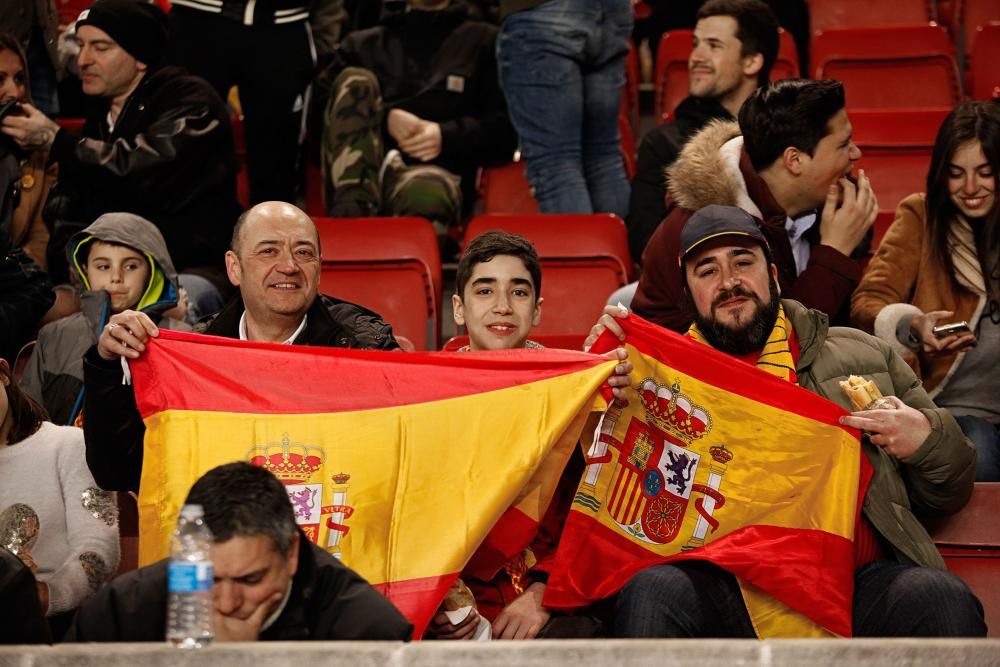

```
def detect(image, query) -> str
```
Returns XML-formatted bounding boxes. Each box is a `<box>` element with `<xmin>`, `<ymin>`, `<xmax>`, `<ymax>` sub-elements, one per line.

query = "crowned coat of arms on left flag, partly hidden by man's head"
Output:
<box><xmin>247</xmin><ymin>433</ymin><xmax>354</xmax><ymax>557</ymax></box>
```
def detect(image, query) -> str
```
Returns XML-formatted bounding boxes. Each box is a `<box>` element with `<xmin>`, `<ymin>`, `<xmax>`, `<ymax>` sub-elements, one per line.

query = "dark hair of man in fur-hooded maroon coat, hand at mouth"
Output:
<box><xmin>740</xmin><ymin>79</ymin><xmax>845</xmax><ymax>171</ymax></box>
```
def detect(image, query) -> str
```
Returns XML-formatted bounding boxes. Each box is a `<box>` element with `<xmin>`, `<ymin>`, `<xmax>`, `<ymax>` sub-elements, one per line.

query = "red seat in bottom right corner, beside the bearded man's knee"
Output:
<box><xmin>925</xmin><ymin>482</ymin><xmax>1000</xmax><ymax>637</ymax></box>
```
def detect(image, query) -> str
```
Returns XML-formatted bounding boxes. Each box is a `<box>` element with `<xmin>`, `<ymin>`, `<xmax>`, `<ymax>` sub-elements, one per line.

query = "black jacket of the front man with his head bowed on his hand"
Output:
<box><xmin>64</xmin><ymin>535</ymin><xmax>413</xmax><ymax>642</ymax></box>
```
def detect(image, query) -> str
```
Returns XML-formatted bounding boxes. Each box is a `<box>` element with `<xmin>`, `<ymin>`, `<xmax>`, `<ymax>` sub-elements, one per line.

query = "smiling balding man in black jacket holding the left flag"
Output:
<box><xmin>83</xmin><ymin>202</ymin><xmax>399</xmax><ymax>491</ymax></box>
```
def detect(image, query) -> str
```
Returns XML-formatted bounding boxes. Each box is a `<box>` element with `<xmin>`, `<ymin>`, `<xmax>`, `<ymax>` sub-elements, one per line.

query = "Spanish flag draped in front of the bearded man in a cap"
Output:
<box><xmin>545</xmin><ymin>316</ymin><xmax>867</xmax><ymax>637</ymax></box>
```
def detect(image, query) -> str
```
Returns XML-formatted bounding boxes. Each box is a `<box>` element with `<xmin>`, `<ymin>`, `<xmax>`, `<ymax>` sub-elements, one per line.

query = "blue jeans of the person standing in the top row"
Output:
<box><xmin>497</xmin><ymin>0</ymin><xmax>632</xmax><ymax>218</ymax></box>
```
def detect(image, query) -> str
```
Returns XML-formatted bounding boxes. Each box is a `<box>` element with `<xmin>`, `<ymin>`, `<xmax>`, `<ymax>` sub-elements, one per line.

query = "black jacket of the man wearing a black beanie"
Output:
<box><xmin>46</xmin><ymin>67</ymin><xmax>240</xmax><ymax>290</ymax></box>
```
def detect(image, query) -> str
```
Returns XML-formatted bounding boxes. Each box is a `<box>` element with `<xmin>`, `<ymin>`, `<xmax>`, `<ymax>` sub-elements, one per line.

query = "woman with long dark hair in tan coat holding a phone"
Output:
<box><xmin>851</xmin><ymin>102</ymin><xmax>1000</xmax><ymax>481</ymax></box>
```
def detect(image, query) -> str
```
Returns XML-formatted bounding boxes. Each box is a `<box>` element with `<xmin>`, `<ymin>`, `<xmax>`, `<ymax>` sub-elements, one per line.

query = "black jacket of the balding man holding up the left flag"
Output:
<box><xmin>83</xmin><ymin>294</ymin><xmax>399</xmax><ymax>492</ymax></box>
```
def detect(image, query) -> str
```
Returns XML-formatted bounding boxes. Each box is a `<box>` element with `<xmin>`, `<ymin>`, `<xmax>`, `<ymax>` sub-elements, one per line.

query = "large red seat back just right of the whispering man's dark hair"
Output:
<box><xmin>812</xmin><ymin>25</ymin><xmax>961</xmax><ymax>109</ymax></box>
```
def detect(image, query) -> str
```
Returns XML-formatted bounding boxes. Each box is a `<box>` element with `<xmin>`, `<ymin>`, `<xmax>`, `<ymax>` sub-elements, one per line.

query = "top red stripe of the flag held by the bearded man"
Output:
<box><xmin>590</xmin><ymin>314</ymin><xmax>860</xmax><ymax>438</ymax></box>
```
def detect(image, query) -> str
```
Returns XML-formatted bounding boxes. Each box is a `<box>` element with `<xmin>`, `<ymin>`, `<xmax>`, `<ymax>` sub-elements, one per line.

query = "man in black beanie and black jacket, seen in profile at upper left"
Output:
<box><xmin>0</xmin><ymin>0</ymin><xmax>240</xmax><ymax>320</ymax></box>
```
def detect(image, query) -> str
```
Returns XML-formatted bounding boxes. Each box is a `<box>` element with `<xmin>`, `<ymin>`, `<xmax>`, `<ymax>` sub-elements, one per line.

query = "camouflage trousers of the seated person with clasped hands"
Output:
<box><xmin>321</xmin><ymin>67</ymin><xmax>462</xmax><ymax>236</ymax></box>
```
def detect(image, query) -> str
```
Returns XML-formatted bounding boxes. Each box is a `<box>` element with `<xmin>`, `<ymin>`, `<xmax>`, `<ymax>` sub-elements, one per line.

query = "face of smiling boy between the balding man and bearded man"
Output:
<box><xmin>451</xmin><ymin>255</ymin><xmax>542</xmax><ymax>350</ymax></box>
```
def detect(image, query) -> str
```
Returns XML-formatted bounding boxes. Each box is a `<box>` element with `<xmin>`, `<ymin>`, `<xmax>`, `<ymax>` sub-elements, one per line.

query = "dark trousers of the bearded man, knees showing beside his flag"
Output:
<box><xmin>615</xmin><ymin>561</ymin><xmax>986</xmax><ymax>638</ymax></box>
